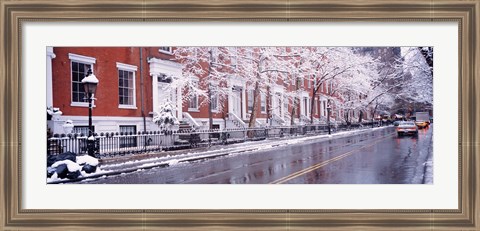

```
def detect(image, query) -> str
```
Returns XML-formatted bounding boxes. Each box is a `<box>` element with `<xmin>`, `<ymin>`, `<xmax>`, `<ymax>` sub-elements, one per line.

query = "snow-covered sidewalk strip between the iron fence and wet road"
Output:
<box><xmin>49</xmin><ymin>126</ymin><xmax>391</xmax><ymax>183</ymax></box>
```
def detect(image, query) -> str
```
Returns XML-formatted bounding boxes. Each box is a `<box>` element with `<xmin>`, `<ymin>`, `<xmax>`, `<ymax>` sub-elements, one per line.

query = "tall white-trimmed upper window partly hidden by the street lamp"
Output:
<box><xmin>68</xmin><ymin>53</ymin><xmax>96</xmax><ymax>107</ymax></box>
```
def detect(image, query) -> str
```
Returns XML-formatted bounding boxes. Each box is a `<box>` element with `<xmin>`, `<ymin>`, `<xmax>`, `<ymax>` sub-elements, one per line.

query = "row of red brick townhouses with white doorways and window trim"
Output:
<box><xmin>46</xmin><ymin>47</ymin><xmax>348</xmax><ymax>134</ymax></box>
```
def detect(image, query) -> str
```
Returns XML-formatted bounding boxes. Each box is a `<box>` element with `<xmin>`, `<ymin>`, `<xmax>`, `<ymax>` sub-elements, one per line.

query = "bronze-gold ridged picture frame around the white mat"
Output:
<box><xmin>0</xmin><ymin>0</ymin><xmax>480</xmax><ymax>230</ymax></box>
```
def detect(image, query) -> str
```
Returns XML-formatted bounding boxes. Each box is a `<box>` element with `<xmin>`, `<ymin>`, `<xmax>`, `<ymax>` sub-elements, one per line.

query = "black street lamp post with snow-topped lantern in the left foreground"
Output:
<box><xmin>82</xmin><ymin>69</ymin><xmax>98</xmax><ymax>157</ymax></box>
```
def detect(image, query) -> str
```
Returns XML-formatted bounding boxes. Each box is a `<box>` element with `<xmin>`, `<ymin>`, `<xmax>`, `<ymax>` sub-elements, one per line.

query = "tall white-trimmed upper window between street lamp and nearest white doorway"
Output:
<box><xmin>117</xmin><ymin>63</ymin><xmax>137</xmax><ymax>109</ymax></box>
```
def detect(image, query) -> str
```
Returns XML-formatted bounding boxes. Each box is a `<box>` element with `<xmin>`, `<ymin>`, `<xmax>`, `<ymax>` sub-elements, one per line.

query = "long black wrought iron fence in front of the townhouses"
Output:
<box><xmin>47</xmin><ymin>122</ymin><xmax>386</xmax><ymax>158</ymax></box>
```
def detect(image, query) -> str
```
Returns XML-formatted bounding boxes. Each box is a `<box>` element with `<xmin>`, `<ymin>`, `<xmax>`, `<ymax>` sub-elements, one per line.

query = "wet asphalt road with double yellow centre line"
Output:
<box><xmin>83</xmin><ymin>126</ymin><xmax>433</xmax><ymax>184</ymax></box>
